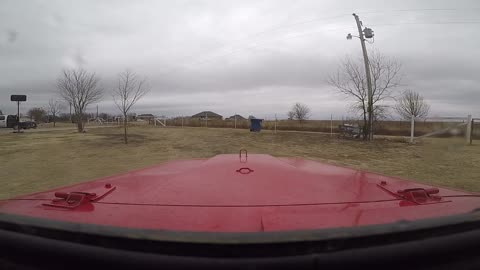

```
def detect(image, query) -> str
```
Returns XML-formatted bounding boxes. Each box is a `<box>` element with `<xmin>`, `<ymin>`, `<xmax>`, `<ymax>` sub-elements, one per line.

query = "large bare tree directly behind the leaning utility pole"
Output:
<box><xmin>327</xmin><ymin>51</ymin><xmax>401</xmax><ymax>139</ymax></box>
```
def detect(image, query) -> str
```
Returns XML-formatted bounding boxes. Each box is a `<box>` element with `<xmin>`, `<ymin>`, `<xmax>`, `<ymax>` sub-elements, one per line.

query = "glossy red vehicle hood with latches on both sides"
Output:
<box><xmin>0</xmin><ymin>154</ymin><xmax>480</xmax><ymax>232</ymax></box>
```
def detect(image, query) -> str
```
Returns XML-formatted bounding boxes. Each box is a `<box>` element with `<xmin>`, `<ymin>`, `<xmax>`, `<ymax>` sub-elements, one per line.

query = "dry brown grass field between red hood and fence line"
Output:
<box><xmin>0</xmin><ymin>126</ymin><xmax>480</xmax><ymax>199</ymax></box>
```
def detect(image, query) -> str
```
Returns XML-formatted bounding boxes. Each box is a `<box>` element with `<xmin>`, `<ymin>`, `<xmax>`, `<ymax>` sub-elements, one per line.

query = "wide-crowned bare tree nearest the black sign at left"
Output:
<box><xmin>57</xmin><ymin>69</ymin><xmax>103</xmax><ymax>132</ymax></box>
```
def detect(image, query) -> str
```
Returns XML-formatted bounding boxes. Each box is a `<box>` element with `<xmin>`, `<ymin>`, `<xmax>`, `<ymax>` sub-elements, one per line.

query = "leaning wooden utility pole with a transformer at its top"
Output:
<box><xmin>347</xmin><ymin>13</ymin><xmax>373</xmax><ymax>140</ymax></box>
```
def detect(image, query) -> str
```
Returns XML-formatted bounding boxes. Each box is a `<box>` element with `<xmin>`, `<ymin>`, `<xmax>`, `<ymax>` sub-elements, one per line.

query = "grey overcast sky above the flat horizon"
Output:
<box><xmin>0</xmin><ymin>0</ymin><xmax>480</xmax><ymax>119</ymax></box>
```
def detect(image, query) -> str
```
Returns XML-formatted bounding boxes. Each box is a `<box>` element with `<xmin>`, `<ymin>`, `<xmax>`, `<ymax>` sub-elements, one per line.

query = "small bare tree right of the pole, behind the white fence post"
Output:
<box><xmin>395</xmin><ymin>90</ymin><xmax>430</xmax><ymax>120</ymax></box>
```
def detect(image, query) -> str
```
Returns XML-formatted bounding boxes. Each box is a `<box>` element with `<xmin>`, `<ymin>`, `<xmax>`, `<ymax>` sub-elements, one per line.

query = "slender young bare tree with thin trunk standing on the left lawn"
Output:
<box><xmin>112</xmin><ymin>70</ymin><xmax>150</xmax><ymax>144</ymax></box>
